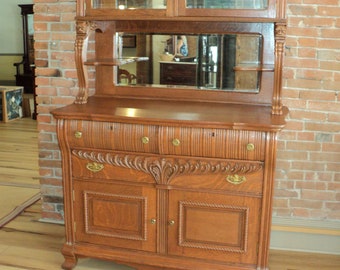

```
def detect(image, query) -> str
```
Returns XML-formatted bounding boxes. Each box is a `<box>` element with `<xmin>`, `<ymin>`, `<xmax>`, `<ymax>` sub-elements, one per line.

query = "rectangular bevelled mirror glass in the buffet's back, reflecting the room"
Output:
<box><xmin>117</xmin><ymin>33</ymin><xmax>263</xmax><ymax>93</ymax></box>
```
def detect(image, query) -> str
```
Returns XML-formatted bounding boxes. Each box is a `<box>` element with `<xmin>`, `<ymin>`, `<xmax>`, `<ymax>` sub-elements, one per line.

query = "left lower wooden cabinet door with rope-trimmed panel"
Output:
<box><xmin>74</xmin><ymin>180</ymin><xmax>156</xmax><ymax>251</ymax></box>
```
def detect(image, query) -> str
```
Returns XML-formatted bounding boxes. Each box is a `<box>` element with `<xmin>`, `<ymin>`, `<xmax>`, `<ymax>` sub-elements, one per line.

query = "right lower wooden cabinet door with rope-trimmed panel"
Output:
<box><xmin>168</xmin><ymin>190</ymin><xmax>261</xmax><ymax>265</ymax></box>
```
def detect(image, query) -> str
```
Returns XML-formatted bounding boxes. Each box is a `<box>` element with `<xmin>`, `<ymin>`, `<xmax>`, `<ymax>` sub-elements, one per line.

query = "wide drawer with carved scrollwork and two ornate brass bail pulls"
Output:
<box><xmin>71</xmin><ymin>149</ymin><xmax>264</xmax><ymax>195</ymax></box>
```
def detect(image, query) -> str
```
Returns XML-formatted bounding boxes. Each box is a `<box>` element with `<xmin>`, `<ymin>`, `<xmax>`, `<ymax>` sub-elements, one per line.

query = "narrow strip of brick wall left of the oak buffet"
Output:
<box><xmin>34</xmin><ymin>0</ymin><xmax>77</xmax><ymax>221</ymax></box>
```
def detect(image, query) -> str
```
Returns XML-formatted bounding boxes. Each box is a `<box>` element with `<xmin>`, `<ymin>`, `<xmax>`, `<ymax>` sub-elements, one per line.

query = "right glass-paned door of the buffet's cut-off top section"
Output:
<box><xmin>178</xmin><ymin>0</ymin><xmax>276</xmax><ymax>18</ymax></box>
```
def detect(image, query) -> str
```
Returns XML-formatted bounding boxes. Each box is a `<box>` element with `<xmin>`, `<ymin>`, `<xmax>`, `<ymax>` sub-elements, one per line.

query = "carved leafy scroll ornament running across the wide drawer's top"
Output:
<box><xmin>72</xmin><ymin>150</ymin><xmax>263</xmax><ymax>184</ymax></box>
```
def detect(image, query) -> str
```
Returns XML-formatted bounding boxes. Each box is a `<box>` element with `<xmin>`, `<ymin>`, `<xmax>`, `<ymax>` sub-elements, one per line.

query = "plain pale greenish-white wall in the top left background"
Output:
<box><xmin>0</xmin><ymin>0</ymin><xmax>33</xmax><ymax>54</ymax></box>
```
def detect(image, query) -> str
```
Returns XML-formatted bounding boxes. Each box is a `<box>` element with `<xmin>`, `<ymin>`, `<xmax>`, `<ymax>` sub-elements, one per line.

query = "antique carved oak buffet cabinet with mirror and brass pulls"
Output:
<box><xmin>53</xmin><ymin>0</ymin><xmax>287</xmax><ymax>270</ymax></box>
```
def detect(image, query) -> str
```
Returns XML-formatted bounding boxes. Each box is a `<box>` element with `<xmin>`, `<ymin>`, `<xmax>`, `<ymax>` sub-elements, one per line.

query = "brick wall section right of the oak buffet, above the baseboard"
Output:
<box><xmin>273</xmin><ymin>0</ymin><xmax>340</xmax><ymax>221</ymax></box>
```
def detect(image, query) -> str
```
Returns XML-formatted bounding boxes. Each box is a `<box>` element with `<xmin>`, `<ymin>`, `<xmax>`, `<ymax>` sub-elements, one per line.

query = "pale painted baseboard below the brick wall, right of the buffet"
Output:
<box><xmin>270</xmin><ymin>218</ymin><xmax>340</xmax><ymax>255</ymax></box>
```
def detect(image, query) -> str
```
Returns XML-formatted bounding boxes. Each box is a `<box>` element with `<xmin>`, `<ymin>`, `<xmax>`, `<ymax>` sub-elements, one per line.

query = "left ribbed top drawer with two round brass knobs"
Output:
<box><xmin>66</xmin><ymin>120</ymin><xmax>158</xmax><ymax>153</ymax></box>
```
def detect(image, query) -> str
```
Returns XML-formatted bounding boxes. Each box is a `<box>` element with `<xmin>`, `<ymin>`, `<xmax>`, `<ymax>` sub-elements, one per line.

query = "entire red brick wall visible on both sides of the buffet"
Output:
<box><xmin>34</xmin><ymin>0</ymin><xmax>340</xmax><ymax>222</ymax></box>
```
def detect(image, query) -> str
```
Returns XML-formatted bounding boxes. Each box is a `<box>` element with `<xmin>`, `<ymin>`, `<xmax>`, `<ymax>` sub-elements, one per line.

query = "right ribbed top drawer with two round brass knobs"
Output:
<box><xmin>160</xmin><ymin>127</ymin><xmax>266</xmax><ymax>161</ymax></box>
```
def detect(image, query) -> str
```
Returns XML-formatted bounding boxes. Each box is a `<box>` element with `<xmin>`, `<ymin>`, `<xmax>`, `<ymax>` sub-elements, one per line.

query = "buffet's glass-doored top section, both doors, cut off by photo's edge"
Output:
<box><xmin>83</xmin><ymin>0</ymin><xmax>280</xmax><ymax>21</ymax></box>
